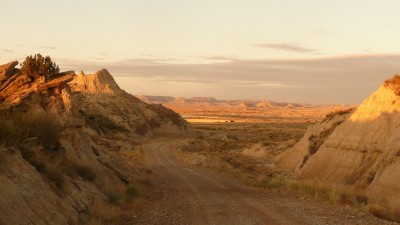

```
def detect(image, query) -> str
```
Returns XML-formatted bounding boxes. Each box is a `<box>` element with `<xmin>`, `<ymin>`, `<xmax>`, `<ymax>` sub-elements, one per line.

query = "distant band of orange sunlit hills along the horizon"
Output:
<box><xmin>136</xmin><ymin>95</ymin><xmax>349</xmax><ymax>121</ymax></box>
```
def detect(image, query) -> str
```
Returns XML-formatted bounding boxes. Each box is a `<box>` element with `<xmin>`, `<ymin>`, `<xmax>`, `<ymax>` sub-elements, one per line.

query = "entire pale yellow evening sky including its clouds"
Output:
<box><xmin>0</xmin><ymin>0</ymin><xmax>400</xmax><ymax>104</ymax></box>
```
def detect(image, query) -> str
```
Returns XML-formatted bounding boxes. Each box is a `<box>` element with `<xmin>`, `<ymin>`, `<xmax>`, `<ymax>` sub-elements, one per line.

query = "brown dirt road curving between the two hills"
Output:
<box><xmin>134</xmin><ymin>141</ymin><xmax>392</xmax><ymax>225</ymax></box>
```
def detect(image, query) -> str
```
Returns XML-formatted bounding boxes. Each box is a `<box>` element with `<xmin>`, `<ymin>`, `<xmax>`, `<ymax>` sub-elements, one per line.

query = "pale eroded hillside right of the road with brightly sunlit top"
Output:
<box><xmin>277</xmin><ymin>75</ymin><xmax>400</xmax><ymax>207</ymax></box>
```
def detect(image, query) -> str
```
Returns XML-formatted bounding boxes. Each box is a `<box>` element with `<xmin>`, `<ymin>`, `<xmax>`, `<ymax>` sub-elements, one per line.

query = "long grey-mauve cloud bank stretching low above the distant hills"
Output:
<box><xmin>56</xmin><ymin>54</ymin><xmax>400</xmax><ymax>104</ymax></box>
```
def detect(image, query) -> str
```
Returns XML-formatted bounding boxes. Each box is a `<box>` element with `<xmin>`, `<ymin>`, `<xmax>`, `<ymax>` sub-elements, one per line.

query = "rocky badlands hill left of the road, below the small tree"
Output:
<box><xmin>0</xmin><ymin>62</ymin><xmax>192</xmax><ymax>224</ymax></box>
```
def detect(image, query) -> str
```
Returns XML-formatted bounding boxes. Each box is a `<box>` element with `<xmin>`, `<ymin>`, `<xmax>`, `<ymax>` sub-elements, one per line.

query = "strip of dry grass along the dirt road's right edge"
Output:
<box><xmin>178</xmin><ymin>146</ymin><xmax>400</xmax><ymax>222</ymax></box>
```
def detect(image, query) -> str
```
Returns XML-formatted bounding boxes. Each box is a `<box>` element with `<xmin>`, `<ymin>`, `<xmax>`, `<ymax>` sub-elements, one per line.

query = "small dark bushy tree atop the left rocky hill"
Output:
<box><xmin>21</xmin><ymin>53</ymin><xmax>60</xmax><ymax>79</ymax></box>
